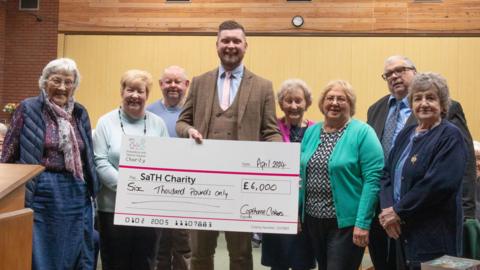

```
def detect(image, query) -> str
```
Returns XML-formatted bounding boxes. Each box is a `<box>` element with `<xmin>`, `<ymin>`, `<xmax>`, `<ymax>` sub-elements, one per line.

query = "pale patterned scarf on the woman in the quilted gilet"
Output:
<box><xmin>42</xmin><ymin>90</ymin><xmax>84</xmax><ymax>180</ymax></box>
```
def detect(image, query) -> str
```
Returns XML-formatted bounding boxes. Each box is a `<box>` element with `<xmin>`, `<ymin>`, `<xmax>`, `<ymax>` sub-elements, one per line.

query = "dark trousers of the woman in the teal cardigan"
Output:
<box><xmin>305</xmin><ymin>215</ymin><xmax>365</xmax><ymax>270</ymax></box>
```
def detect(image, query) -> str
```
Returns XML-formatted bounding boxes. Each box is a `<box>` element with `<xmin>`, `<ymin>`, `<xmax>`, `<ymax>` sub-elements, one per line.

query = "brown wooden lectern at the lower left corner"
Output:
<box><xmin>0</xmin><ymin>163</ymin><xmax>44</xmax><ymax>269</ymax></box>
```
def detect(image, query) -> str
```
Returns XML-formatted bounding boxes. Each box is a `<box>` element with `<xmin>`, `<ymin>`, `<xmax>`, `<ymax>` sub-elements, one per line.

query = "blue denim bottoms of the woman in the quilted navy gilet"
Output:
<box><xmin>30</xmin><ymin>172</ymin><xmax>94</xmax><ymax>270</ymax></box>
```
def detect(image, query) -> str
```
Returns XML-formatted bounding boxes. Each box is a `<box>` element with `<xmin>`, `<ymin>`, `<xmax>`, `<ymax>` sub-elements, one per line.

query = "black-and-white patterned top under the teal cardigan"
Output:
<box><xmin>305</xmin><ymin>125</ymin><xmax>347</xmax><ymax>218</ymax></box>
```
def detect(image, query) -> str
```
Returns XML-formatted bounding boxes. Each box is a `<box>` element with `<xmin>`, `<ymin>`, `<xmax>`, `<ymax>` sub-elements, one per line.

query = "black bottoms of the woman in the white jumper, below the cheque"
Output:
<box><xmin>98</xmin><ymin>211</ymin><xmax>159</xmax><ymax>270</ymax></box>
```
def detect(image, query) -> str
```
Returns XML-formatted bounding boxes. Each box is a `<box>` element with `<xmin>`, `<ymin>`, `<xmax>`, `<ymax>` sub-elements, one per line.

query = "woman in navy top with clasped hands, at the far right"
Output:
<box><xmin>379</xmin><ymin>73</ymin><xmax>467</xmax><ymax>269</ymax></box>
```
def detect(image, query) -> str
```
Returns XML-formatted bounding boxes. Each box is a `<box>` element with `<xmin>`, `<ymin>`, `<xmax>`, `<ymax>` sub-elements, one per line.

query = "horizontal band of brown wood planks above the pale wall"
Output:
<box><xmin>59</xmin><ymin>0</ymin><xmax>480</xmax><ymax>35</ymax></box>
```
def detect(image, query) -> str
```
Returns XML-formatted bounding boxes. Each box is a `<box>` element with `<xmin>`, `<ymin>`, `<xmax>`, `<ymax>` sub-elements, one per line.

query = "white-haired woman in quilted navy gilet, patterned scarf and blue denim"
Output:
<box><xmin>1</xmin><ymin>58</ymin><xmax>98</xmax><ymax>269</ymax></box>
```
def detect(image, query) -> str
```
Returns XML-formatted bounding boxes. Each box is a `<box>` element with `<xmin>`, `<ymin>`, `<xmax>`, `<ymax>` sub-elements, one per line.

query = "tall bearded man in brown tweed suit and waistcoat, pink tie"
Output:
<box><xmin>176</xmin><ymin>21</ymin><xmax>282</xmax><ymax>270</ymax></box>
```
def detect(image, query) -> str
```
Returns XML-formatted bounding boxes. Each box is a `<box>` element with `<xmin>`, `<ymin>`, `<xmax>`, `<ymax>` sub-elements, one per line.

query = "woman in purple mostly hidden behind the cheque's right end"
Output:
<box><xmin>262</xmin><ymin>79</ymin><xmax>315</xmax><ymax>270</ymax></box>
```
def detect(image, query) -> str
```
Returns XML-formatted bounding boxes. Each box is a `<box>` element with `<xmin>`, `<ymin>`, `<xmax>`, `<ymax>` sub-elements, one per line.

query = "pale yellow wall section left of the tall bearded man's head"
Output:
<box><xmin>65</xmin><ymin>35</ymin><xmax>217</xmax><ymax>126</ymax></box>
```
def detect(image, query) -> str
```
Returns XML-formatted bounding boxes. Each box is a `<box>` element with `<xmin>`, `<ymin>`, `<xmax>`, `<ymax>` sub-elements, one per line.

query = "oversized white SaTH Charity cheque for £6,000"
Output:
<box><xmin>114</xmin><ymin>136</ymin><xmax>300</xmax><ymax>234</ymax></box>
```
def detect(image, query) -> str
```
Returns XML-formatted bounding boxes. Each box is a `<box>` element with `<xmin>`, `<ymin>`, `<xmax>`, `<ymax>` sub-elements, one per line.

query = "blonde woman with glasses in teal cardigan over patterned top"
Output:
<box><xmin>300</xmin><ymin>80</ymin><xmax>383</xmax><ymax>270</ymax></box>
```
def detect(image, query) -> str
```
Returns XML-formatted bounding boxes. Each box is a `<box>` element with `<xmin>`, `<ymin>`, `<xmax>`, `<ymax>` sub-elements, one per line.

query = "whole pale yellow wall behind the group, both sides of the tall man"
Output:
<box><xmin>58</xmin><ymin>34</ymin><xmax>480</xmax><ymax>140</ymax></box>
